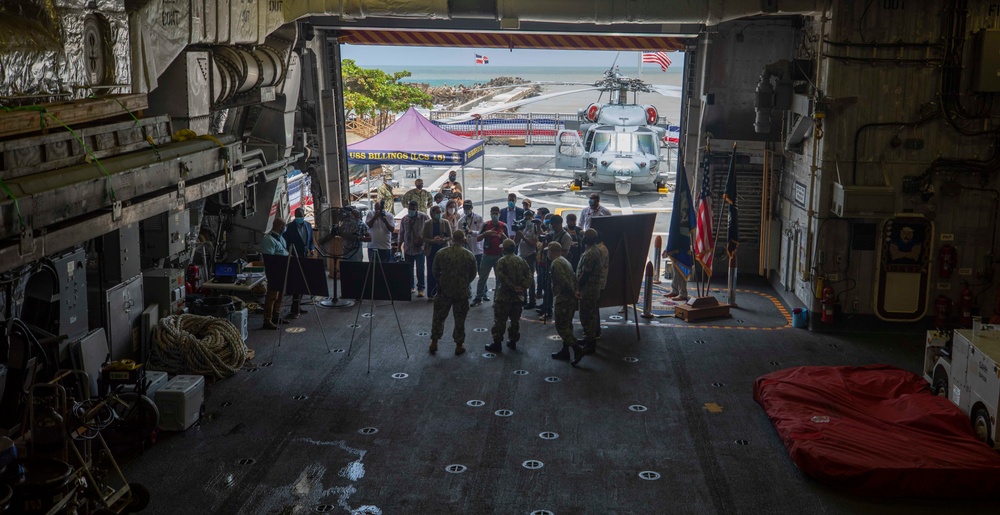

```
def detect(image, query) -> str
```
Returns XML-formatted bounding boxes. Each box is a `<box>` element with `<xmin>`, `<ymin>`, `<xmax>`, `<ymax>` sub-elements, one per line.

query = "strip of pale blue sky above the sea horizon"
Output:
<box><xmin>341</xmin><ymin>45</ymin><xmax>684</xmax><ymax>70</ymax></box>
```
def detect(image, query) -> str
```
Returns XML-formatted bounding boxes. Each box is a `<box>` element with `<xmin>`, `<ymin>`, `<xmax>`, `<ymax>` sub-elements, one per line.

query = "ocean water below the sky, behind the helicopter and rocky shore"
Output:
<box><xmin>379</xmin><ymin>64</ymin><xmax>683</xmax><ymax>123</ymax></box>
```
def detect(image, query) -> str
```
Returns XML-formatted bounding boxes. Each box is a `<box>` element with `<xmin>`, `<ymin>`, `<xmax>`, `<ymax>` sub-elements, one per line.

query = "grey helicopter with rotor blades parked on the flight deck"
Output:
<box><xmin>435</xmin><ymin>66</ymin><xmax>681</xmax><ymax>195</ymax></box>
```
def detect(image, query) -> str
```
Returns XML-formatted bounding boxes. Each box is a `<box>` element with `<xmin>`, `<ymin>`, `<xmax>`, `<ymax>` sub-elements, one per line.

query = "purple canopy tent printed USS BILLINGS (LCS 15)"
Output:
<box><xmin>347</xmin><ymin>107</ymin><xmax>486</xmax><ymax>203</ymax></box>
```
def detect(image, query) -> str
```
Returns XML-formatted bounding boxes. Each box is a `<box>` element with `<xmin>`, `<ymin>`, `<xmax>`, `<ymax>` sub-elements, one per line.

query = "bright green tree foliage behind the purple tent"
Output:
<box><xmin>341</xmin><ymin>59</ymin><xmax>433</xmax><ymax>130</ymax></box>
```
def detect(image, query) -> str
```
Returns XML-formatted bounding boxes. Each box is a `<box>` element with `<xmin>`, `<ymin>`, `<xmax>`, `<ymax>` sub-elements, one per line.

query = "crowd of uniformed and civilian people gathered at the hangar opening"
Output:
<box><xmin>384</xmin><ymin>176</ymin><xmax>611</xmax><ymax>364</ymax></box>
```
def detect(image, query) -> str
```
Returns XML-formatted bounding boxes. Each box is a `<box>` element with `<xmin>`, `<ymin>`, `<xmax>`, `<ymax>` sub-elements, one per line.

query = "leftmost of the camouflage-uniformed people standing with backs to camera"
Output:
<box><xmin>429</xmin><ymin>231</ymin><xmax>476</xmax><ymax>356</ymax></box>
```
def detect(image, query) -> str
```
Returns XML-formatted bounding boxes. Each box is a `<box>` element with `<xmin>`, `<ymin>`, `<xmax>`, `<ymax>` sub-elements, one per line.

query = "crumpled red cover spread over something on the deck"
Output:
<box><xmin>753</xmin><ymin>365</ymin><xmax>1000</xmax><ymax>499</ymax></box>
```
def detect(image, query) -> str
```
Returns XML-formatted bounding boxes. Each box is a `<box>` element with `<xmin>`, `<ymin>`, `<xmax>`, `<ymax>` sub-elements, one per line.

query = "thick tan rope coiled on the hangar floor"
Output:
<box><xmin>149</xmin><ymin>315</ymin><xmax>247</xmax><ymax>379</ymax></box>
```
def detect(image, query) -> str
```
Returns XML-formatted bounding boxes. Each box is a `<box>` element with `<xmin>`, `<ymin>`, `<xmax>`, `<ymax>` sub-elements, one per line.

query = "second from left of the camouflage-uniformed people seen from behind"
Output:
<box><xmin>486</xmin><ymin>240</ymin><xmax>531</xmax><ymax>352</ymax></box>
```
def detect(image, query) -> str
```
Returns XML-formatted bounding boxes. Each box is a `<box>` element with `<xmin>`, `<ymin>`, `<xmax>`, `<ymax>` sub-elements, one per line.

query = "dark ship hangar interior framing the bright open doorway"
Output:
<box><xmin>0</xmin><ymin>0</ymin><xmax>1000</xmax><ymax>514</ymax></box>
